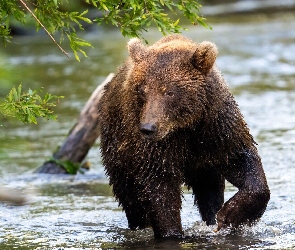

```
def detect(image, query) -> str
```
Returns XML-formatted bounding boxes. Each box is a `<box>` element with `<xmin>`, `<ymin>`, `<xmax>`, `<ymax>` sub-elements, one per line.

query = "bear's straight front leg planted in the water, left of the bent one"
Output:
<box><xmin>148</xmin><ymin>180</ymin><xmax>183</xmax><ymax>239</ymax></box>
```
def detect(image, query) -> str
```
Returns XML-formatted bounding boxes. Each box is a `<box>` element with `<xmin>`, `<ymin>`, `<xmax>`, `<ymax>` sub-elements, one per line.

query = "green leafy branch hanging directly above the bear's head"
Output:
<box><xmin>92</xmin><ymin>0</ymin><xmax>209</xmax><ymax>42</ymax></box>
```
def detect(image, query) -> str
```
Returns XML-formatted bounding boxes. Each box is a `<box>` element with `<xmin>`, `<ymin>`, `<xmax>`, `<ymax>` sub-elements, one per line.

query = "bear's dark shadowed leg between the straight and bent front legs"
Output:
<box><xmin>186</xmin><ymin>167</ymin><xmax>225</xmax><ymax>225</ymax></box>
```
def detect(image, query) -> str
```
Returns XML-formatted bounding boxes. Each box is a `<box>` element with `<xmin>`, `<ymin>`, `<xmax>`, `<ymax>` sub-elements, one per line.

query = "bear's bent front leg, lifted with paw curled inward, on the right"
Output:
<box><xmin>217</xmin><ymin>148</ymin><xmax>270</xmax><ymax>230</ymax></box>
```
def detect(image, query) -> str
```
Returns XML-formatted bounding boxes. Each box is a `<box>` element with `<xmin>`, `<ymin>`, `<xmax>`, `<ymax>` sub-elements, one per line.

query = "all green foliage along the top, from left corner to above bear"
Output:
<box><xmin>0</xmin><ymin>0</ymin><xmax>208</xmax><ymax>60</ymax></box>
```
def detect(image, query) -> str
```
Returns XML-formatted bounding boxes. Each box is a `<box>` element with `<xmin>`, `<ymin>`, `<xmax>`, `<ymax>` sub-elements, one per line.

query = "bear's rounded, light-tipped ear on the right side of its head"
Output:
<box><xmin>192</xmin><ymin>41</ymin><xmax>218</xmax><ymax>75</ymax></box>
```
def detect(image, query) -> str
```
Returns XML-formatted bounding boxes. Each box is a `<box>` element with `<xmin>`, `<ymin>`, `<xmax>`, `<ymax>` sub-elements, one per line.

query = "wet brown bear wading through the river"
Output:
<box><xmin>99</xmin><ymin>35</ymin><xmax>270</xmax><ymax>238</ymax></box>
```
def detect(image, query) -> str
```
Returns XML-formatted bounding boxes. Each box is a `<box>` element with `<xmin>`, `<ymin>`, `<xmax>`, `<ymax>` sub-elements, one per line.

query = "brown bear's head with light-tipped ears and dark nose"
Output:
<box><xmin>124</xmin><ymin>35</ymin><xmax>217</xmax><ymax>140</ymax></box>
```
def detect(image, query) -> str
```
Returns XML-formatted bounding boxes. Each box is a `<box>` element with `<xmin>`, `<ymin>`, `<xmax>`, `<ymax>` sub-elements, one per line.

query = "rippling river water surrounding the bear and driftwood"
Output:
<box><xmin>0</xmin><ymin>4</ymin><xmax>295</xmax><ymax>249</ymax></box>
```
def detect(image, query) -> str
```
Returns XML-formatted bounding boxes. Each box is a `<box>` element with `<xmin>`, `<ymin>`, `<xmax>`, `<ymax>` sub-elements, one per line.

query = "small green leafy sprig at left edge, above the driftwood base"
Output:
<box><xmin>0</xmin><ymin>84</ymin><xmax>63</xmax><ymax>124</ymax></box>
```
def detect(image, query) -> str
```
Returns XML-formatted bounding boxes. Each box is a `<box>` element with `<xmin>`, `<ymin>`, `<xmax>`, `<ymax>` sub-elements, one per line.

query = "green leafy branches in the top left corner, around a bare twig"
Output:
<box><xmin>0</xmin><ymin>0</ymin><xmax>92</xmax><ymax>60</ymax></box>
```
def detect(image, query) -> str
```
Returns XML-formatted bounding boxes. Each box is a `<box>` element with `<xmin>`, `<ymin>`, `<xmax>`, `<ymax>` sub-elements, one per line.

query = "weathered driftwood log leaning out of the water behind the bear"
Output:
<box><xmin>36</xmin><ymin>73</ymin><xmax>114</xmax><ymax>174</ymax></box>
